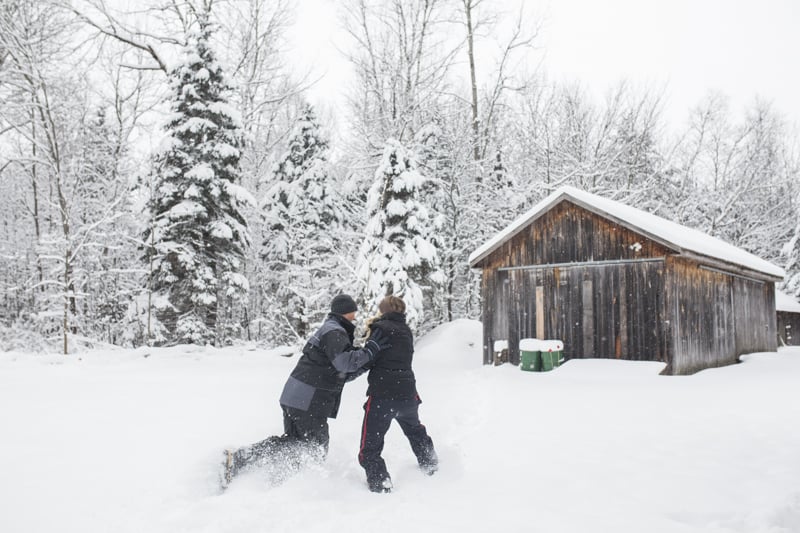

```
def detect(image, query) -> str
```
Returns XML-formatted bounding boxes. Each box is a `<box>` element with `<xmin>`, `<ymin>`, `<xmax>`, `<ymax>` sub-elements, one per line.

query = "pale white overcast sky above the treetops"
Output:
<box><xmin>290</xmin><ymin>0</ymin><xmax>800</xmax><ymax>130</ymax></box>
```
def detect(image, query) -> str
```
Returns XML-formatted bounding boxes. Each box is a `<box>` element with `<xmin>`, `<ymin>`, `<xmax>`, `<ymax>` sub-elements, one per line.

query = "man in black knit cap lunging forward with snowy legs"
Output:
<box><xmin>221</xmin><ymin>294</ymin><xmax>388</xmax><ymax>488</ymax></box>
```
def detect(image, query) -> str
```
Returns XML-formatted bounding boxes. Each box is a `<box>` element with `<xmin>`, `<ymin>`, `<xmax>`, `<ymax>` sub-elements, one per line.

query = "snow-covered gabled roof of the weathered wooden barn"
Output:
<box><xmin>469</xmin><ymin>186</ymin><xmax>784</xmax><ymax>279</ymax></box>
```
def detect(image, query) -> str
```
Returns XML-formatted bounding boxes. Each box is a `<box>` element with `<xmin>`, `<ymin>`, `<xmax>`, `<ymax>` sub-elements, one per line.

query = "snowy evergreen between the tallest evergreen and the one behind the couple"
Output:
<box><xmin>261</xmin><ymin>104</ymin><xmax>343</xmax><ymax>342</ymax></box>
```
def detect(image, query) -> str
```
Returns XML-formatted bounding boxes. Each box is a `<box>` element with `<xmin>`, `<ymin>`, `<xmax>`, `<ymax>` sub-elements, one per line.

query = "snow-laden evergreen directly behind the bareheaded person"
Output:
<box><xmin>358</xmin><ymin>139</ymin><xmax>444</xmax><ymax>329</ymax></box>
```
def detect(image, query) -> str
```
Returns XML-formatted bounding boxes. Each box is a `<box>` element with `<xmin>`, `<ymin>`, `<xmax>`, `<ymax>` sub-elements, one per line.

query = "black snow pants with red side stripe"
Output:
<box><xmin>358</xmin><ymin>396</ymin><xmax>437</xmax><ymax>488</ymax></box>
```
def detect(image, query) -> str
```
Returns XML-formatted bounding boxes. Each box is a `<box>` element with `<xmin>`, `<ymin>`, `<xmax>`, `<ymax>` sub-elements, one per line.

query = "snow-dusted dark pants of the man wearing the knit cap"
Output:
<box><xmin>233</xmin><ymin>406</ymin><xmax>330</xmax><ymax>482</ymax></box>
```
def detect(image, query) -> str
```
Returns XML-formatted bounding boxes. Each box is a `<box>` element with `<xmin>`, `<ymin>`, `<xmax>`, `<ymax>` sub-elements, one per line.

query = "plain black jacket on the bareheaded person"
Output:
<box><xmin>367</xmin><ymin>312</ymin><xmax>417</xmax><ymax>400</ymax></box>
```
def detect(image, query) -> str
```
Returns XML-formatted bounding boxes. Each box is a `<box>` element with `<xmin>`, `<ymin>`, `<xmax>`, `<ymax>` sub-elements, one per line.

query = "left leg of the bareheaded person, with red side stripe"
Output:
<box><xmin>358</xmin><ymin>396</ymin><xmax>394</xmax><ymax>492</ymax></box>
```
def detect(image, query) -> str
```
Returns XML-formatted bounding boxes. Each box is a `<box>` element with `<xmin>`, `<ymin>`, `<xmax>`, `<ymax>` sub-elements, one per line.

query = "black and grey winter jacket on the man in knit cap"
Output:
<box><xmin>280</xmin><ymin>313</ymin><xmax>370</xmax><ymax>418</ymax></box>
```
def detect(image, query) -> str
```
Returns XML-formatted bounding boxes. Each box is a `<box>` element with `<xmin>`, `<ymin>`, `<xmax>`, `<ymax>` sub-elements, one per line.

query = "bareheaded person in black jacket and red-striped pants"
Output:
<box><xmin>358</xmin><ymin>296</ymin><xmax>438</xmax><ymax>492</ymax></box>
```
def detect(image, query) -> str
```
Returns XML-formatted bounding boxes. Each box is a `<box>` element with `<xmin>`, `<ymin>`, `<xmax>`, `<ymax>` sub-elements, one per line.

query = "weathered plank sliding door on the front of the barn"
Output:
<box><xmin>492</xmin><ymin>260</ymin><xmax>669</xmax><ymax>364</ymax></box>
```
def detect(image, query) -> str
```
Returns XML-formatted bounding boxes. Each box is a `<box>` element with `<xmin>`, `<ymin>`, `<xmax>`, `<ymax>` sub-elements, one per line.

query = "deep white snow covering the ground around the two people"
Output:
<box><xmin>0</xmin><ymin>321</ymin><xmax>800</xmax><ymax>533</ymax></box>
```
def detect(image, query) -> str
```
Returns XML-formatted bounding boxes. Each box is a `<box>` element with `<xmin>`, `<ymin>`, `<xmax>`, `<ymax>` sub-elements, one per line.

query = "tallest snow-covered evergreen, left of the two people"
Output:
<box><xmin>144</xmin><ymin>11</ymin><xmax>253</xmax><ymax>344</ymax></box>
